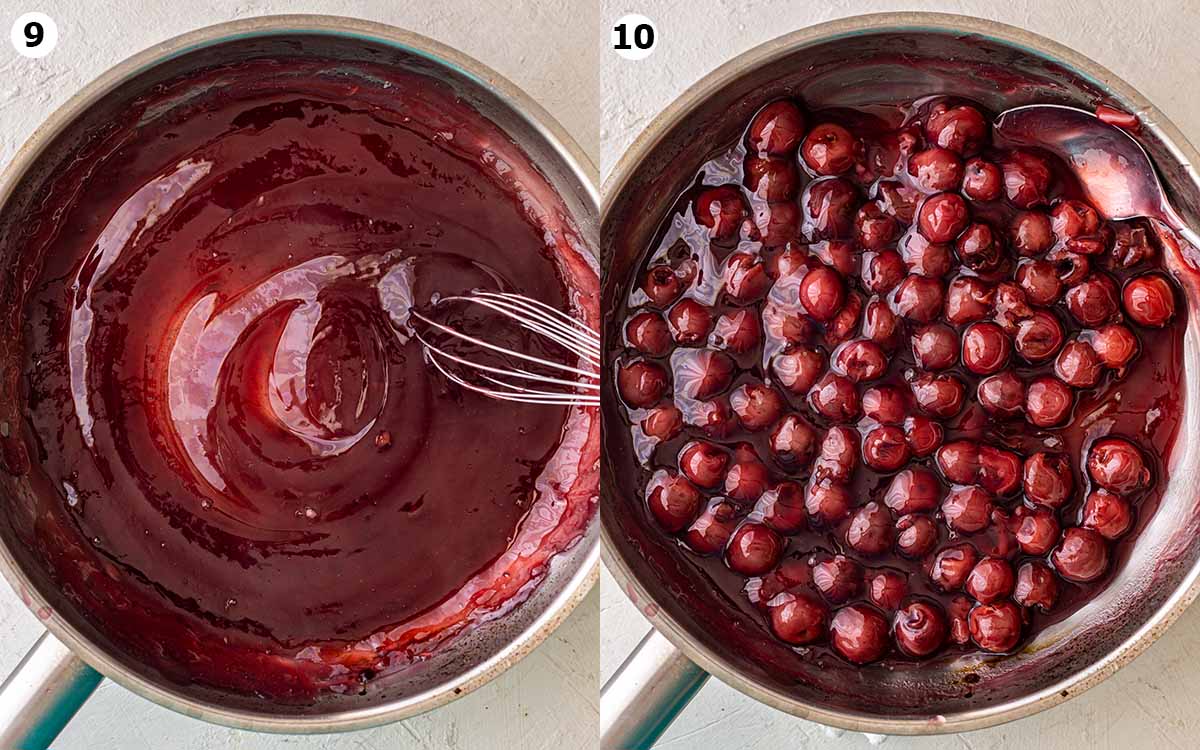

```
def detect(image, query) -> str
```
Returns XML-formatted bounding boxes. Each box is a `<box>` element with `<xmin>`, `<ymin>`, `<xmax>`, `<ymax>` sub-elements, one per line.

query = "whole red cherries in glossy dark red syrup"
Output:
<box><xmin>611</xmin><ymin>97</ymin><xmax>1186</xmax><ymax>665</ymax></box>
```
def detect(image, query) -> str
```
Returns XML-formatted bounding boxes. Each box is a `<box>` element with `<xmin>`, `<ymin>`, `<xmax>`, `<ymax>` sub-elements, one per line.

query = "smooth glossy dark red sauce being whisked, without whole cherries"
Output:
<box><xmin>6</xmin><ymin>60</ymin><xmax>599</xmax><ymax>701</ymax></box>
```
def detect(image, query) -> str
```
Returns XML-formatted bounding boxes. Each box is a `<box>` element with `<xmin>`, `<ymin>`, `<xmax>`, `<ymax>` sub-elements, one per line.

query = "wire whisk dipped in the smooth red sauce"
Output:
<box><xmin>412</xmin><ymin>292</ymin><xmax>600</xmax><ymax>406</ymax></box>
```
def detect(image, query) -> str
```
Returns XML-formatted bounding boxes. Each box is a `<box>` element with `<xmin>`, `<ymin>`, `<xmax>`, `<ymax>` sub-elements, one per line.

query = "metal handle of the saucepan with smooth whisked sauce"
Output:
<box><xmin>0</xmin><ymin>632</ymin><xmax>102</xmax><ymax>750</ymax></box>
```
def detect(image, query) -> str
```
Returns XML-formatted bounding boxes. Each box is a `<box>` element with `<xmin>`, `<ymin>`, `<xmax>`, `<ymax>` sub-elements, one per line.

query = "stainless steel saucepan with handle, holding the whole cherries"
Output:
<box><xmin>601</xmin><ymin>13</ymin><xmax>1200</xmax><ymax>748</ymax></box>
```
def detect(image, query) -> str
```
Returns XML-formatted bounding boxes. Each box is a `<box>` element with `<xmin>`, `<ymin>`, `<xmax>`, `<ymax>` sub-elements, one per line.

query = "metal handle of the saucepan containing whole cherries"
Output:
<box><xmin>600</xmin><ymin>629</ymin><xmax>708</xmax><ymax>750</ymax></box>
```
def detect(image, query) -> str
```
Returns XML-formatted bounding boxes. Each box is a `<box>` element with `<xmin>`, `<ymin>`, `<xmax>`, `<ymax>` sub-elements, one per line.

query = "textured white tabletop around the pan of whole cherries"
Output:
<box><xmin>600</xmin><ymin>0</ymin><xmax>1200</xmax><ymax>750</ymax></box>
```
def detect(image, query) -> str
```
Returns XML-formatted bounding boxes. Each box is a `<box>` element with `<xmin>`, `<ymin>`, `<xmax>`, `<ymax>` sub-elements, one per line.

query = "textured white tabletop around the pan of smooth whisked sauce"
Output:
<box><xmin>0</xmin><ymin>0</ymin><xmax>600</xmax><ymax>750</ymax></box>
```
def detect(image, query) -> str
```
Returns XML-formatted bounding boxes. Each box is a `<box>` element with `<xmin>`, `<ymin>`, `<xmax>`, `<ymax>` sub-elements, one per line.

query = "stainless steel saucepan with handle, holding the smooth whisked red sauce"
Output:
<box><xmin>0</xmin><ymin>16</ymin><xmax>599</xmax><ymax>748</ymax></box>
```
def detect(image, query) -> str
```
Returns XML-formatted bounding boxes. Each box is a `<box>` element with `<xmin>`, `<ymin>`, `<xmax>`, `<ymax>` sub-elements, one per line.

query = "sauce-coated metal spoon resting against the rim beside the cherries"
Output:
<box><xmin>994</xmin><ymin>104</ymin><xmax>1200</xmax><ymax>257</ymax></box>
